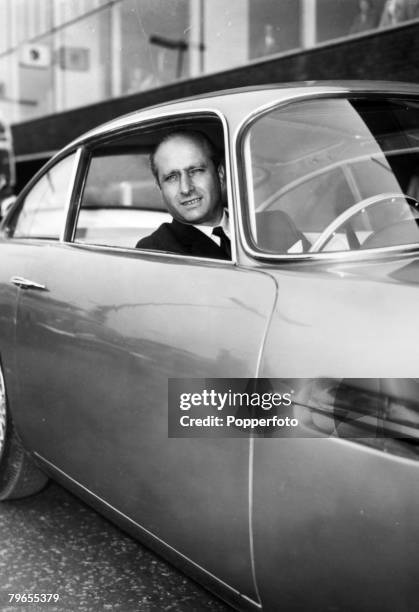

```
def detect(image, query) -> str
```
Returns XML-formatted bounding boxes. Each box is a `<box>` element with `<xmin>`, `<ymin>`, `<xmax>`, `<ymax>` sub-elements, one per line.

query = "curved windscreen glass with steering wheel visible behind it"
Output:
<box><xmin>244</xmin><ymin>98</ymin><xmax>419</xmax><ymax>253</ymax></box>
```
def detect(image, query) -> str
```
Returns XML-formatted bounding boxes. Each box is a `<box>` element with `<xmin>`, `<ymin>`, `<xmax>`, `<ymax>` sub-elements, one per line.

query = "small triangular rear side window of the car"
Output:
<box><xmin>9</xmin><ymin>153</ymin><xmax>76</xmax><ymax>240</ymax></box>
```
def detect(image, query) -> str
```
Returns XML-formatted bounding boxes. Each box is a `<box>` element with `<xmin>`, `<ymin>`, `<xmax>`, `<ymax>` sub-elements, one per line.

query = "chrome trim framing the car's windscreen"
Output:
<box><xmin>232</xmin><ymin>87</ymin><xmax>419</xmax><ymax>263</ymax></box>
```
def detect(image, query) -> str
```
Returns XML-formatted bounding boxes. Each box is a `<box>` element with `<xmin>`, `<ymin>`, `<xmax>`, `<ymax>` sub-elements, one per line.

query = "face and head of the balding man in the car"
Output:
<box><xmin>154</xmin><ymin>135</ymin><xmax>224</xmax><ymax>225</ymax></box>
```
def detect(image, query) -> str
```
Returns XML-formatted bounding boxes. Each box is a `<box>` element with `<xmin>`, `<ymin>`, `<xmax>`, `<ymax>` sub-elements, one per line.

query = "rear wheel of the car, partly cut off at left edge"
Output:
<box><xmin>0</xmin><ymin>366</ymin><xmax>48</xmax><ymax>501</ymax></box>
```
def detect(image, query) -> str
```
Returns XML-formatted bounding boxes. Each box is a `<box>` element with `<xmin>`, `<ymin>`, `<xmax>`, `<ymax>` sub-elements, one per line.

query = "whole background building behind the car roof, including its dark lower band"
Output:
<box><xmin>0</xmin><ymin>0</ymin><xmax>419</xmax><ymax>189</ymax></box>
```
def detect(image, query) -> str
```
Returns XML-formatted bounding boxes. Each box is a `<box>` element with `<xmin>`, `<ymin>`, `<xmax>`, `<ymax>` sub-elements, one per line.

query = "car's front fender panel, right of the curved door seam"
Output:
<box><xmin>252</xmin><ymin>258</ymin><xmax>419</xmax><ymax>612</ymax></box>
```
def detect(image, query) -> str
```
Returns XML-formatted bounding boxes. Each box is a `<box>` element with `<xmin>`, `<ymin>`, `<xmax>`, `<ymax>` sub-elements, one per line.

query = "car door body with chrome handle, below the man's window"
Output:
<box><xmin>8</xmin><ymin>122</ymin><xmax>275</xmax><ymax>599</ymax></box>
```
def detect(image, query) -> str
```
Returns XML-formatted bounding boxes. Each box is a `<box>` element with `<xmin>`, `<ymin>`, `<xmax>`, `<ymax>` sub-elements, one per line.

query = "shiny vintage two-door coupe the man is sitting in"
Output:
<box><xmin>0</xmin><ymin>81</ymin><xmax>419</xmax><ymax>612</ymax></box>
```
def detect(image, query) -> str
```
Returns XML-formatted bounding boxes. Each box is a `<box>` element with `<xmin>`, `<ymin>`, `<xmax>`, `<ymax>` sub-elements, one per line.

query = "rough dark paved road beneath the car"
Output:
<box><xmin>0</xmin><ymin>484</ymin><xmax>232</xmax><ymax>612</ymax></box>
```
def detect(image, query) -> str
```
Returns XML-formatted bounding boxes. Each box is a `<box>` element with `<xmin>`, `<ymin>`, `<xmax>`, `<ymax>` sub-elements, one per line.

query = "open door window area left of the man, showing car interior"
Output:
<box><xmin>74</xmin><ymin>149</ymin><xmax>171</xmax><ymax>248</ymax></box>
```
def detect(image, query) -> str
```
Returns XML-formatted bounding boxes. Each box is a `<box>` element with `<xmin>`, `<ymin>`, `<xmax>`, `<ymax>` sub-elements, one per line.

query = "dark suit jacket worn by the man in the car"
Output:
<box><xmin>136</xmin><ymin>219</ymin><xmax>230</xmax><ymax>259</ymax></box>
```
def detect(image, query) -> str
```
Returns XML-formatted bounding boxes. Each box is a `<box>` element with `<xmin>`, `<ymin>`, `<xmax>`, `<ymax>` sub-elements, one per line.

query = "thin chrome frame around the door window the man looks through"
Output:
<box><xmin>67</xmin><ymin>108</ymin><xmax>238</xmax><ymax>265</ymax></box>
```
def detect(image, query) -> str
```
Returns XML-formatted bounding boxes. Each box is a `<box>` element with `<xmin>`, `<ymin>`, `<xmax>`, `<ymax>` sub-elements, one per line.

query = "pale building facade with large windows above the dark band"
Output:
<box><xmin>0</xmin><ymin>0</ymin><xmax>419</xmax><ymax>123</ymax></box>
